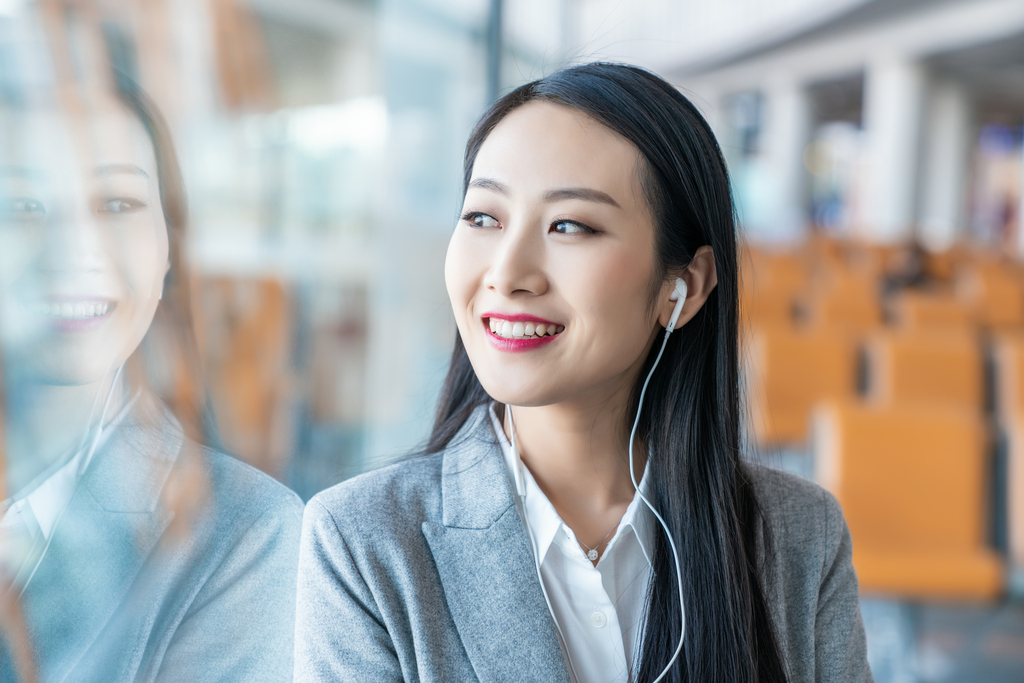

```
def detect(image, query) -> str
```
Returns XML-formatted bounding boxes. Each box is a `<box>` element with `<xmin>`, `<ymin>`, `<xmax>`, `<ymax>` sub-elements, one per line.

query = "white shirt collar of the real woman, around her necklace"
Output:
<box><xmin>489</xmin><ymin>402</ymin><xmax>657</xmax><ymax>564</ymax></box>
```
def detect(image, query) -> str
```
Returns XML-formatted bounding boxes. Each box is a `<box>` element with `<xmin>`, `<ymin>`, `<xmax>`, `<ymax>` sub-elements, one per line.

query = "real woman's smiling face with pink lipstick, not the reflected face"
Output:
<box><xmin>444</xmin><ymin>101</ymin><xmax>671</xmax><ymax>405</ymax></box>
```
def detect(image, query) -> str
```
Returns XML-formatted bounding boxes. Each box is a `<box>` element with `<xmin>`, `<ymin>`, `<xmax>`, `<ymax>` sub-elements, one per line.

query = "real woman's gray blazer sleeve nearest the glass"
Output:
<box><xmin>295</xmin><ymin>499</ymin><xmax>403</xmax><ymax>683</ymax></box>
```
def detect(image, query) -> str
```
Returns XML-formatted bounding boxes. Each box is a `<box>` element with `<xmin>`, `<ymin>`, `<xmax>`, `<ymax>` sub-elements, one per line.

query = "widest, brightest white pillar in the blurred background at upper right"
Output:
<box><xmin>863</xmin><ymin>56</ymin><xmax>925</xmax><ymax>243</ymax></box>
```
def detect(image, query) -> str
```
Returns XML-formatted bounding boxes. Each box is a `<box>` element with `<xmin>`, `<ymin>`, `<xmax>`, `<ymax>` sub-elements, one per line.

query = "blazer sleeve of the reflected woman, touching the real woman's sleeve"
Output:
<box><xmin>156</xmin><ymin>497</ymin><xmax>302</xmax><ymax>683</ymax></box>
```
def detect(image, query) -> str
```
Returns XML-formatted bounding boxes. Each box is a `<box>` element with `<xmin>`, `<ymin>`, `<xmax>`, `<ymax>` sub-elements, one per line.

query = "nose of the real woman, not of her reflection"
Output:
<box><xmin>484</xmin><ymin>216</ymin><xmax>550</xmax><ymax>298</ymax></box>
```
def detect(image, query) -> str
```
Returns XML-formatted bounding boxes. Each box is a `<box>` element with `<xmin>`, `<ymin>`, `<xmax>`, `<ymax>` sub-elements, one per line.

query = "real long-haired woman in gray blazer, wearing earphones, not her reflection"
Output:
<box><xmin>296</xmin><ymin>63</ymin><xmax>870</xmax><ymax>683</ymax></box>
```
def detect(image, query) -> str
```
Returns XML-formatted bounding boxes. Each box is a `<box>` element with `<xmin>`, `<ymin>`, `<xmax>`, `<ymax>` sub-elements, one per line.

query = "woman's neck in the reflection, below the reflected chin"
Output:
<box><xmin>0</xmin><ymin>373</ymin><xmax>124</xmax><ymax>497</ymax></box>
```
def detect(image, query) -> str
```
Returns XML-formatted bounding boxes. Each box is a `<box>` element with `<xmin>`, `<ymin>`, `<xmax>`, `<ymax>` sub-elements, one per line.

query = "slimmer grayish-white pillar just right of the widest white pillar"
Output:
<box><xmin>920</xmin><ymin>82</ymin><xmax>971</xmax><ymax>251</ymax></box>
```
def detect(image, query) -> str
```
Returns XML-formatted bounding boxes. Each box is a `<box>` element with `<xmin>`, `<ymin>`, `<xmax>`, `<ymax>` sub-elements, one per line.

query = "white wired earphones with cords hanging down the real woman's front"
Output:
<box><xmin>508</xmin><ymin>278</ymin><xmax>687</xmax><ymax>683</ymax></box>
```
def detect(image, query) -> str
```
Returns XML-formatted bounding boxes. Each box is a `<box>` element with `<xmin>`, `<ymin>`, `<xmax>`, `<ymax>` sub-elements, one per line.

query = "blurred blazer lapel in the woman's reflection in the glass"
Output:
<box><xmin>23</xmin><ymin>403</ymin><xmax>181</xmax><ymax>681</ymax></box>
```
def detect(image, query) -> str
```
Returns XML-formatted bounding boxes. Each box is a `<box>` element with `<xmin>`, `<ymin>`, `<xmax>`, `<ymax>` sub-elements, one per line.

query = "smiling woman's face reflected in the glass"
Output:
<box><xmin>0</xmin><ymin>102</ymin><xmax>168</xmax><ymax>385</ymax></box>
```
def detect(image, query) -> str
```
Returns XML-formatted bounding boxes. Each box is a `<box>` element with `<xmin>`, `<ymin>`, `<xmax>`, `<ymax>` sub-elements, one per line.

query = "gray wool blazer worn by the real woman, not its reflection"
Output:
<box><xmin>295</xmin><ymin>409</ymin><xmax>871</xmax><ymax>683</ymax></box>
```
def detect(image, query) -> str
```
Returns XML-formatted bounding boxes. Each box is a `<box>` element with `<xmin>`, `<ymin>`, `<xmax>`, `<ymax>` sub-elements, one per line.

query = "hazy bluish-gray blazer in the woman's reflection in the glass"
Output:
<box><xmin>0</xmin><ymin>401</ymin><xmax>302</xmax><ymax>683</ymax></box>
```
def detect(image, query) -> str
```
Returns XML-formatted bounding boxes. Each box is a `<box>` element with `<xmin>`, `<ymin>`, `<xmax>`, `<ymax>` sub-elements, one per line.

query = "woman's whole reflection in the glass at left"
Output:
<box><xmin>0</xmin><ymin>34</ymin><xmax>301</xmax><ymax>683</ymax></box>
